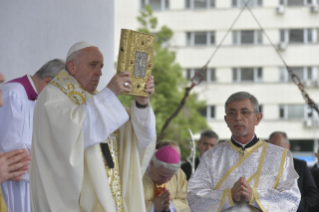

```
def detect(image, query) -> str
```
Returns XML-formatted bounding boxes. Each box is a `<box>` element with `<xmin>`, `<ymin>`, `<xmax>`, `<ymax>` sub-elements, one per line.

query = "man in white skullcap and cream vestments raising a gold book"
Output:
<box><xmin>30</xmin><ymin>42</ymin><xmax>156</xmax><ymax>212</ymax></box>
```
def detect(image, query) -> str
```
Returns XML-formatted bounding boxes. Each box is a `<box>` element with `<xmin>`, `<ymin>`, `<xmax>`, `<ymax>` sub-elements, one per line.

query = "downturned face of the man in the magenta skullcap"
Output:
<box><xmin>150</xmin><ymin>161</ymin><xmax>175</xmax><ymax>185</ymax></box>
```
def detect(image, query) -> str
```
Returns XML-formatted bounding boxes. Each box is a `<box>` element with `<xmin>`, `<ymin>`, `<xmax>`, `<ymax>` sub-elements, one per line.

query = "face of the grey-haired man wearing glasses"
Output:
<box><xmin>224</xmin><ymin>99</ymin><xmax>262</xmax><ymax>141</ymax></box>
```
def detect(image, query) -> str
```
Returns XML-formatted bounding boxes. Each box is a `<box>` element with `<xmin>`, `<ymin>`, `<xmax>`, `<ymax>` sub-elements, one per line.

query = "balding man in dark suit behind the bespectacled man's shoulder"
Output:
<box><xmin>269</xmin><ymin>131</ymin><xmax>319</xmax><ymax>212</ymax></box>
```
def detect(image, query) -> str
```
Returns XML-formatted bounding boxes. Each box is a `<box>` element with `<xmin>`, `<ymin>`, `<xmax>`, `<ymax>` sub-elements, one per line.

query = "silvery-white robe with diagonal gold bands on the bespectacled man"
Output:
<box><xmin>187</xmin><ymin>140</ymin><xmax>300</xmax><ymax>212</ymax></box>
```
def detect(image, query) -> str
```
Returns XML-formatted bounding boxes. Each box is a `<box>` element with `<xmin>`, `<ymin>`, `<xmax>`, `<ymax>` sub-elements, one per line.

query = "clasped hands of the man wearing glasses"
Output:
<box><xmin>231</xmin><ymin>177</ymin><xmax>253</xmax><ymax>203</ymax></box>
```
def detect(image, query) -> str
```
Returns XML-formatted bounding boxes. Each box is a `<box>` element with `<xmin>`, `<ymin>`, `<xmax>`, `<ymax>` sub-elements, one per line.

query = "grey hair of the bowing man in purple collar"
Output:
<box><xmin>34</xmin><ymin>59</ymin><xmax>65</xmax><ymax>80</ymax></box>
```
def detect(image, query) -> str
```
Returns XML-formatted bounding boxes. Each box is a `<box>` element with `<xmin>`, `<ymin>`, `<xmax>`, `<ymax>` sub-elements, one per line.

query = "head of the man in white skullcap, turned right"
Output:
<box><xmin>66</xmin><ymin>41</ymin><xmax>103</xmax><ymax>94</ymax></box>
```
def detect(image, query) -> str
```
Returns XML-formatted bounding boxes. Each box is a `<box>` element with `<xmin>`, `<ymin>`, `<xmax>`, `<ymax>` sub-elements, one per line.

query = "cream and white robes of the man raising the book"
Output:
<box><xmin>30</xmin><ymin>70</ymin><xmax>155</xmax><ymax>212</ymax></box>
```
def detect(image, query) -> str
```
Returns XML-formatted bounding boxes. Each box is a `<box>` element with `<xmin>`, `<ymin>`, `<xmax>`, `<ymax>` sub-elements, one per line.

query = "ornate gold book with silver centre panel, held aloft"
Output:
<box><xmin>117</xmin><ymin>29</ymin><xmax>155</xmax><ymax>97</ymax></box>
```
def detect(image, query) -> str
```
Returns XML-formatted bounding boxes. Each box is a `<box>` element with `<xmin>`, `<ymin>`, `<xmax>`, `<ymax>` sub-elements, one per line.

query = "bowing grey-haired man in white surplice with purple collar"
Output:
<box><xmin>0</xmin><ymin>59</ymin><xmax>65</xmax><ymax>212</ymax></box>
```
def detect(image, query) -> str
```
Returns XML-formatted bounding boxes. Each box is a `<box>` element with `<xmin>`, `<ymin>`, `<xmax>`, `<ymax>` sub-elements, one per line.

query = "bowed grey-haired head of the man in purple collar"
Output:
<box><xmin>32</xmin><ymin>59</ymin><xmax>65</xmax><ymax>93</ymax></box>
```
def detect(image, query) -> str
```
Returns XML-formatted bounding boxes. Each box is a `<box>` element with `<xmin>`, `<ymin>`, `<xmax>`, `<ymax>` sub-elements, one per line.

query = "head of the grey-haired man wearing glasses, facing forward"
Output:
<box><xmin>224</xmin><ymin>92</ymin><xmax>262</xmax><ymax>144</ymax></box>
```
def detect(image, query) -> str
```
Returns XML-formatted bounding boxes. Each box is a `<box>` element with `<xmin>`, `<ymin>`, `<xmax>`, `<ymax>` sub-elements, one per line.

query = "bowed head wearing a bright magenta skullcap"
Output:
<box><xmin>149</xmin><ymin>146</ymin><xmax>181</xmax><ymax>185</ymax></box>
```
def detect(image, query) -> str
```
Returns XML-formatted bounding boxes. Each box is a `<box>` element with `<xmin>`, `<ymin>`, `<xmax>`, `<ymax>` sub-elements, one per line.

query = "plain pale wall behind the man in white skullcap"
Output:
<box><xmin>0</xmin><ymin>0</ymin><xmax>114</xmax><ymax>89</ymax></box>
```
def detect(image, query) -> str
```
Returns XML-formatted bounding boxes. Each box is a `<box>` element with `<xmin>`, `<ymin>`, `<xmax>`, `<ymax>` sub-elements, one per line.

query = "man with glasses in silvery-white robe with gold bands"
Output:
<box><xmin>187</xmin><ymin>92</ymin><xmax>300</xmax><ymax>212</ymax></box>
